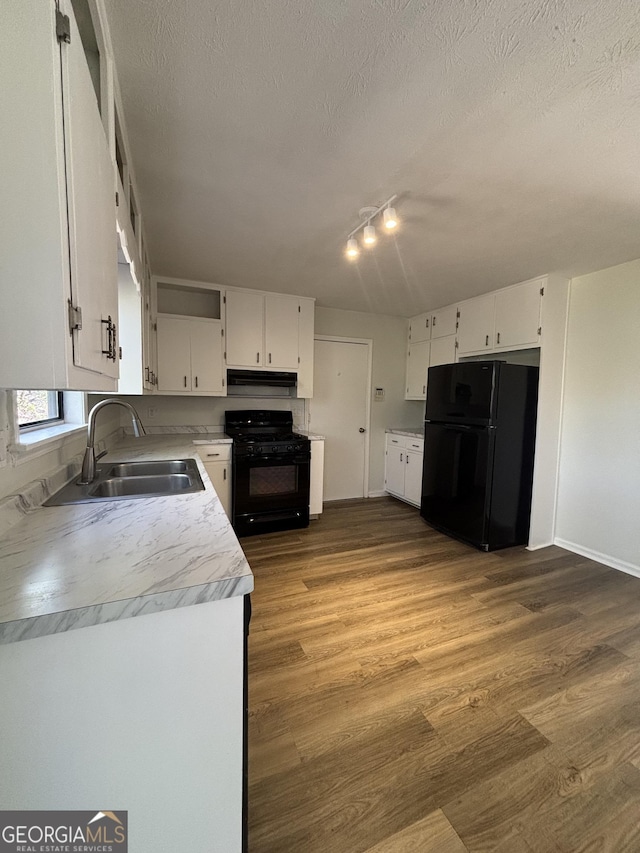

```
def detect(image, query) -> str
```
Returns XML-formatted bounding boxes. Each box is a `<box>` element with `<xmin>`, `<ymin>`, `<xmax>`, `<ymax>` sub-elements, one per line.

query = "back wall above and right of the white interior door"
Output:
<box><xmin>309</xmin><ymin>306</ymin><xmax>424</xmax><ymax>494</ymax></box>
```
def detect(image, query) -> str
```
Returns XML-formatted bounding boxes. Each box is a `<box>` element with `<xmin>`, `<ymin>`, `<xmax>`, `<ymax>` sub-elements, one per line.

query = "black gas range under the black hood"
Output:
<box><xmin>225</xmin><ymin>409</ymin><xmax>311</xmax><ymax>536</ymax></box>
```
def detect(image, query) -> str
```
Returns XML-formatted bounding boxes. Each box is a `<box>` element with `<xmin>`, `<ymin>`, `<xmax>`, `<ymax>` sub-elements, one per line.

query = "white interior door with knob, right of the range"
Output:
<box><xmin>310</xmin><ymin>338</ymin><xmax>371</xmax><ymax>501</ymax></box>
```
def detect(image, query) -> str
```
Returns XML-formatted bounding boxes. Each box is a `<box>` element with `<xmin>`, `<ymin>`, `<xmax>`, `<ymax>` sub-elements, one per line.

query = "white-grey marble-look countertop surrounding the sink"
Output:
<box><xmin>0</xmin><ymin>435</ymin><xmax>253</xmax><ymax>643</ymax></box>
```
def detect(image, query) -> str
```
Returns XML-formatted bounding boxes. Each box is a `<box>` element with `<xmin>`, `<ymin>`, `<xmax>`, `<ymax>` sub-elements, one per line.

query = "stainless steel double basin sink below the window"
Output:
<box><xmin>44</xmin><ymin>459</ymin><xmax>204</xmax><ymax>506</ymax></box>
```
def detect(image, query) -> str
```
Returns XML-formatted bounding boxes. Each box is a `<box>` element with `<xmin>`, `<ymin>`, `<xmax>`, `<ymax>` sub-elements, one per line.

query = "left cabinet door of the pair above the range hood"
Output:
<box><xmin>226</xmin><ymin>290</ymin><xmax>264</xmax><ymax>367</ymax></box>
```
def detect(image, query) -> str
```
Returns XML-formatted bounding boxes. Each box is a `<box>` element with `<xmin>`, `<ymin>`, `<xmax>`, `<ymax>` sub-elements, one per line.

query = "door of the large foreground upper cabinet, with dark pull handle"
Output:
<box><xmin>61</xmin><ymin>3</ymin><xmax>119</xmax><ymax>378</ymax></box>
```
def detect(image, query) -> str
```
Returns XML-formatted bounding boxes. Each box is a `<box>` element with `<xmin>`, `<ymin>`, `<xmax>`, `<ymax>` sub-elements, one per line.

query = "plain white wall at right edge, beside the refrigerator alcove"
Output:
<box><xmin>555</xmin><ymin>260</ymin><xmax>640</xmax><ymax>575</ymax></box>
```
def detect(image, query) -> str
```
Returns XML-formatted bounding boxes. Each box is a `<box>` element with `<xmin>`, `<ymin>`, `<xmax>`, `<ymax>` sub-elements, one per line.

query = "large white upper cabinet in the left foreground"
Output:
<box><xmin>0</xmin><ymin>0</ymin><xmax>118</xmax><ymax>391</ymax></box>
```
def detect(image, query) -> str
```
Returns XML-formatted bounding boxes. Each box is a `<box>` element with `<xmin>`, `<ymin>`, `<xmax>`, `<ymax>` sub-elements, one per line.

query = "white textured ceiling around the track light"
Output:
<box><xmin>106</xmin><ymin>0</ymin><xmax>640</xmax><ymax>316</ymax></box>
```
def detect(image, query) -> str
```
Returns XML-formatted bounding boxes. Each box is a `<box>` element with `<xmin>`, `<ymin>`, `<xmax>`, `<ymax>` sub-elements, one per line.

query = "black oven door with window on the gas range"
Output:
<box><xmin>233</xmin><ymin>451</ymin><xmax>311</xmax><ymax>536</ymax></box>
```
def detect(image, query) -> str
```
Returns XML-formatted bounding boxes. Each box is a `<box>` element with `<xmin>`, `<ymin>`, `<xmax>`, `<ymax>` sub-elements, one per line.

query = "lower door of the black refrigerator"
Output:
<box><xmin>420</xmin><ymin>422</ymin><xmax>495</xmax><ymax>549</ymax></box>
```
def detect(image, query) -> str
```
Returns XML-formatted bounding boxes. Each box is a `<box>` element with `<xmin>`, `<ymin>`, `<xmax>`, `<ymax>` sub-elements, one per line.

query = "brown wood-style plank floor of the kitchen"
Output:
<box><xmin>242</xmin><ymin>498</ymin><xmax>640</xmax><ymax>853</ymax></box>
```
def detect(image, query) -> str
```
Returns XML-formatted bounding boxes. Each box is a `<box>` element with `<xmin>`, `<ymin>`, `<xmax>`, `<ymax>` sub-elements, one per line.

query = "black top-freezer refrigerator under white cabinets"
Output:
<box><xmin>420</xmin><ymin>361</ymin><xmax>538</xmax><ymax>551</ymax></box>
